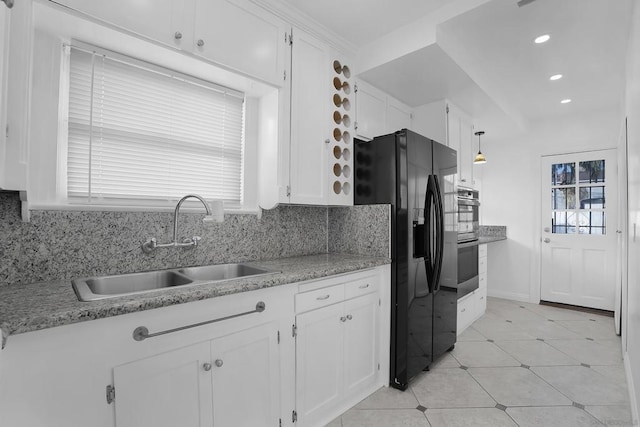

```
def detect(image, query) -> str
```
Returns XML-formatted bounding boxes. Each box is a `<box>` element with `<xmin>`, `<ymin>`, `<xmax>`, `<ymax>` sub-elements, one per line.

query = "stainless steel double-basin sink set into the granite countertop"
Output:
<box><xmin>71</xmin><ymin>264</ymin><xmax>279</xmax><ymax>301</ymax></box>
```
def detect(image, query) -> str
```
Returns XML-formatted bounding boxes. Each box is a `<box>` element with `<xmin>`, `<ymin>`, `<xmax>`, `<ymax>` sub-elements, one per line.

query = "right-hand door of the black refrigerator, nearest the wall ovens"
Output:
<box><xmin>433</xmin><ymin>141</ymin><xmax>458</xmax><ymax>359</ymax></box>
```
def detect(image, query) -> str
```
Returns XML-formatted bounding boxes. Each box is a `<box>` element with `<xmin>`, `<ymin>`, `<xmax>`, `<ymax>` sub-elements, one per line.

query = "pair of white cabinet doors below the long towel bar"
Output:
<box><xmin>113</xmin><ymin>323</ymin><xmax>280</xmax><ymax>427</ymax></box>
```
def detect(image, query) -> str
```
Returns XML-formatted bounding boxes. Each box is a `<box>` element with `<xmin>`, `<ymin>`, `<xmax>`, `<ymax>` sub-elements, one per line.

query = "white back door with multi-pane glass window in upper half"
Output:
<box><xmin>540</xmin><ymin>150</ymin><xmax>618</xmax><ymax>310</ymax></box>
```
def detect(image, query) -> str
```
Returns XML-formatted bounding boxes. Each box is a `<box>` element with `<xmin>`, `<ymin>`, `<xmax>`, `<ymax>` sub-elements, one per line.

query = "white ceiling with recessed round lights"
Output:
<box><xmin>278</xmin><ymin>0</ymin><xmax>634</xmax><ymax>135</ymax></box>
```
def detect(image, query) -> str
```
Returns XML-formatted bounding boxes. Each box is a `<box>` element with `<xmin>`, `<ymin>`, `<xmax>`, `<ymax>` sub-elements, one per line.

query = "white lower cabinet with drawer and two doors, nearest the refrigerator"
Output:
<box><xmin>296</xmin><ymin>276</ymin><xmax>382</xmax><ymax>426</ymax></box>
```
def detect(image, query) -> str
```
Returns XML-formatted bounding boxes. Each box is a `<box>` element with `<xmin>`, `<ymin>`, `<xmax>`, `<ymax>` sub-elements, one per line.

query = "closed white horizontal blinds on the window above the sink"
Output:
<box><xmin>67</xmin><ymin>47</ymin><xmax>244</xmax><ymax>208</ymax></box>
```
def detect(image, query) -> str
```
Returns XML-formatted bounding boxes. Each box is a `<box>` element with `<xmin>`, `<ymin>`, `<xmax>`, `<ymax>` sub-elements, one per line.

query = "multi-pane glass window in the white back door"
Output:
<box><xmin>551</xmin><ymin>160</ymin><xmax>606</xmax><ymax>234</ymax></box>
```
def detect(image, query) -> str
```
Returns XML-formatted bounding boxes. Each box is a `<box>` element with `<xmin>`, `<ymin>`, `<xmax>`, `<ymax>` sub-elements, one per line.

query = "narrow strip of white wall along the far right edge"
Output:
<box><xmin>622</xmin><ymin>3</ymin><xmax>640</xmax><ymax>425</ymax></box>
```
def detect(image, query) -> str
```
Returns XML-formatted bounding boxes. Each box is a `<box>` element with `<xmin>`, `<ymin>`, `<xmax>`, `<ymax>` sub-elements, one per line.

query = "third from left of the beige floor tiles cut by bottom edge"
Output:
<box><xmin>507</xmin><ymin>406</ymin><xmax>602</xmax><ymax>427</ymax></box>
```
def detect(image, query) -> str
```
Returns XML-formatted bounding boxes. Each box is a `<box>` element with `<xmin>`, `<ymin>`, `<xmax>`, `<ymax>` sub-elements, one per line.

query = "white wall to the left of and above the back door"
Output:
<box><xmin>482</xmin><ymin>108</ymin><xmax>621</xmax><ymax>303</ymax></box>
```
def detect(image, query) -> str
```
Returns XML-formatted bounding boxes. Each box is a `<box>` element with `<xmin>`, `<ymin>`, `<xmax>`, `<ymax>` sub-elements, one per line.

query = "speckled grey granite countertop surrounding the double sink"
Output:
<box><xmin>0</xmin><ymin>254</ymin><xmax>391</xmax><ymax>347</ymax></box>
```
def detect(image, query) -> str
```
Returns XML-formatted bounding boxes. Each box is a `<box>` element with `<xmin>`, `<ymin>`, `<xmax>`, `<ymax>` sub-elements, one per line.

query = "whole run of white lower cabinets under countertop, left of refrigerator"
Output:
<box><xmin>0</xmin><ymin>265</ymin><xmax>390</xmax><ymax>427</ymax></box>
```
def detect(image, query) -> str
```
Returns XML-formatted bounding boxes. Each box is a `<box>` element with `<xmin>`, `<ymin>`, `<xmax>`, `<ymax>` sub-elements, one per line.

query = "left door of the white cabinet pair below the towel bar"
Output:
<box><xmin>113</xmin><ymin>342</ymin><xmax>213</xmax><ymax>427</ymax></box>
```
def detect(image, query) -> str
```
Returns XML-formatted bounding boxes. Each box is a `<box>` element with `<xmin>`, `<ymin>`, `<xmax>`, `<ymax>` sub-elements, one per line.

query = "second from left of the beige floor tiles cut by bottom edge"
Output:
<box><xmin>425</xmin><ymin>408</ymin><xmax>517</xmax><ymax>427</ymax></box>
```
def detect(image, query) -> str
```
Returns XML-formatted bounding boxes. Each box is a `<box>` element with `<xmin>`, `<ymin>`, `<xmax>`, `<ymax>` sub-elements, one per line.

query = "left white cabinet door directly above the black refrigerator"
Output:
<box><xmin>356</xmin><ymin>81</ymin><xmax>387</xmax><ymax>139</ymax></box>
